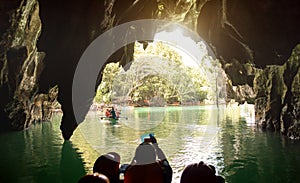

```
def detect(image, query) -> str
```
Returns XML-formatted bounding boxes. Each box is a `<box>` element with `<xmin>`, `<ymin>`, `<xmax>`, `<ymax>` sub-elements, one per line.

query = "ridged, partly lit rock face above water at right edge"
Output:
<box><xmin>254</xmin><ymin>45</ymin><xmax>300</xmax><ymax>139</ymax></box>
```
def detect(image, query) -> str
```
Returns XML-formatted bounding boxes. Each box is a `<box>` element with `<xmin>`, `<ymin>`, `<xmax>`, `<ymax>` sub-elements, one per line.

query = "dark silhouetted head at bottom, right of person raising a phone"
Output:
<box><xmin>180</xmin><ymin>161</ymin><xmax>223</xmax><ymax>183</ymax></box>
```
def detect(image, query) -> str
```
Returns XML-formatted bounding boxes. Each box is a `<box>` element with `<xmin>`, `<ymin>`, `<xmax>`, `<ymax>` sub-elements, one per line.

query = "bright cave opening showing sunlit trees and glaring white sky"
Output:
<box><xmin>94</xmin><ymin>29</ymin><xmax>226</xmax><ymax>108</ymax></box>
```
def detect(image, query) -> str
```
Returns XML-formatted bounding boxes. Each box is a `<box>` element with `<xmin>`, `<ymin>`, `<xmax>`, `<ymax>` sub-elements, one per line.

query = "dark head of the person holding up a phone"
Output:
<box><xmin>134</xmin><ymin>143</ymin><xmax>156</xmax><ymax>165</ymax></box>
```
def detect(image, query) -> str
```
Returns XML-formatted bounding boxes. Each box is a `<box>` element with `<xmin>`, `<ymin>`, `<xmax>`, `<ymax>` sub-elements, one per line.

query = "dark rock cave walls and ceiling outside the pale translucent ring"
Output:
<box><xmin>0</xmin><ymin>0</ymin><xmax>300</xmax><ymax>139</ymax></box>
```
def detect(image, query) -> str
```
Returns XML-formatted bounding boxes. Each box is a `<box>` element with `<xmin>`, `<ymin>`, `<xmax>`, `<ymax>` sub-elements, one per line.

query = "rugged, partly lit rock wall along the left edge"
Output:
<box><xmin>0</xmin><ymin>0</ymin><xmax>56</xmax><ymax>130</ymax></box>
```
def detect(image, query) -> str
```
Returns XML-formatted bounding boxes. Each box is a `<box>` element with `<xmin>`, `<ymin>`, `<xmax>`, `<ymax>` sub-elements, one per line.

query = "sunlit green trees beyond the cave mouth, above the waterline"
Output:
<box><xmin>95</xmin><ymin>42</ymin><xmax>225</xmax><ymax>106</ymax></box>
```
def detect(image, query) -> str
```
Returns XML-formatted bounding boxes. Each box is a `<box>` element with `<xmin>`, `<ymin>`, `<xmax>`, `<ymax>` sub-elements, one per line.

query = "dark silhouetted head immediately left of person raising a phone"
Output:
<box><xmin>93</xmin><ymin>152</ymin><xmax>120</xmax><ymax>182</ymax></box>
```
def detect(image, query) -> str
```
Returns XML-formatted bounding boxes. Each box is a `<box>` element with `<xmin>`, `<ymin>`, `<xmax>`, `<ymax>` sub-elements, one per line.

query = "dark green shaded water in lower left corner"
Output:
<box><xmin>0</xmin><ymin>118</ymin><xmax>86</xmax><ymax>183</ymax></box>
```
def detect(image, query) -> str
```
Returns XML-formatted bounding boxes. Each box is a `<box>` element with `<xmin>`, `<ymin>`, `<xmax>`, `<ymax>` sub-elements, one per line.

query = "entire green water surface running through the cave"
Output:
<box><xmin>0</xmin><ymin>106</ymin><xmax>300</xmax><ymax>183</ymax></box>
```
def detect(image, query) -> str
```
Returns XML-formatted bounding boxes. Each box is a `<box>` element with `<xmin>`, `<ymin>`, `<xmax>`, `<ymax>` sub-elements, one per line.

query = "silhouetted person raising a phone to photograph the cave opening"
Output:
<box><xmin>124</xmin><ymin>136</ymin><xmax>172</xmax><ymax>183</ymax></box>
